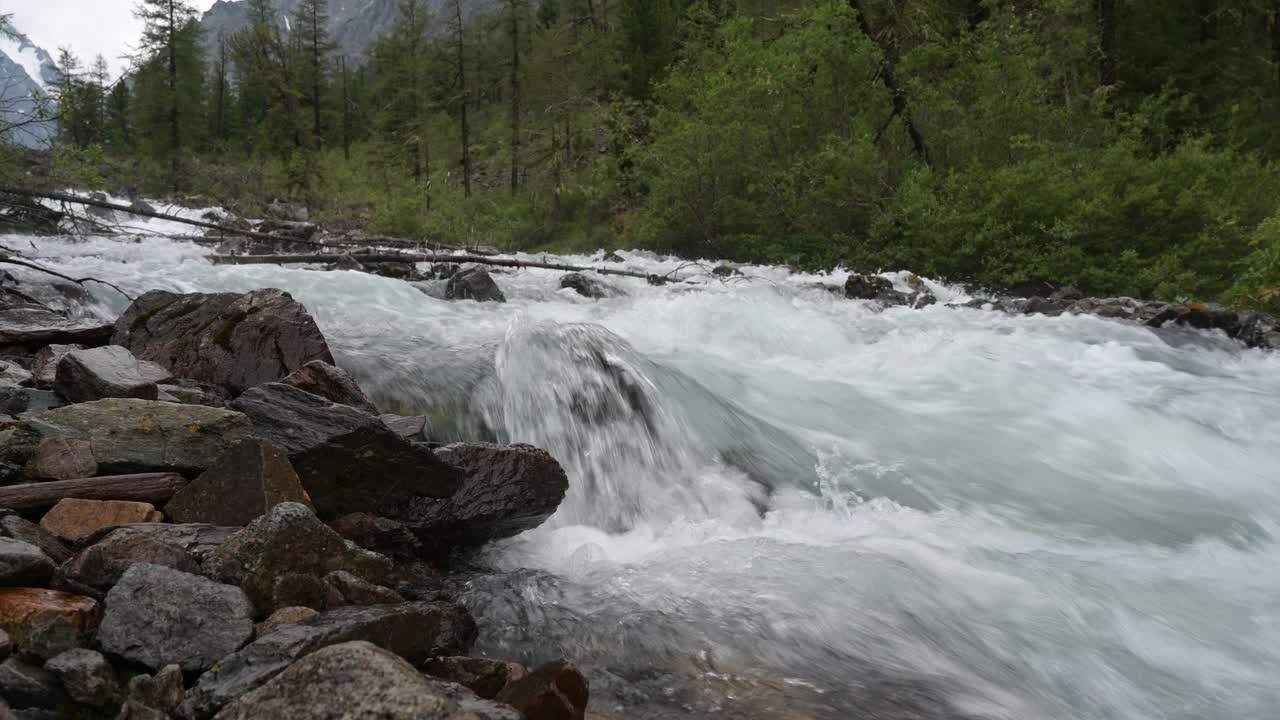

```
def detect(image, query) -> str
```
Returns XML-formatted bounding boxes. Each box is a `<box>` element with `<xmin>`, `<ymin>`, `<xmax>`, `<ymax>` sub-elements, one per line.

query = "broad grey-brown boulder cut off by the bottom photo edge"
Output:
<box><xmin>207</xmin><ymin>642</ymin><xmax>521</xmax><ymax>720</ymax></box>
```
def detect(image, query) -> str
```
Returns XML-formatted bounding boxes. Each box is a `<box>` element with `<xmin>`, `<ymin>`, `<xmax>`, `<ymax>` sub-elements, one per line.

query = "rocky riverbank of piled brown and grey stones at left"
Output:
<box><xmin>0</xmin><ymin>283</ymin><xmax>589</xmax><ymax>720</ymax></box>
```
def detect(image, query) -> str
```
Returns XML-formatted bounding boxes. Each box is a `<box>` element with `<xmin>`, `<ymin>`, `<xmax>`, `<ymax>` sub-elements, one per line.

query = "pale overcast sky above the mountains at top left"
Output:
<box><xmin>0</xmin><ymin>0</ymin><xmax>214</xmax><ymax>72</ymax></box>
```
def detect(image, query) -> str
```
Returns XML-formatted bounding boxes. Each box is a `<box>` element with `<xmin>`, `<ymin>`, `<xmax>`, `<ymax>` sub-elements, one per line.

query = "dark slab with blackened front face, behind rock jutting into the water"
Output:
<box><xmin>232</xmin><ymin>383</ymin><xmax>462</xmax><ymax>518</ymax></box>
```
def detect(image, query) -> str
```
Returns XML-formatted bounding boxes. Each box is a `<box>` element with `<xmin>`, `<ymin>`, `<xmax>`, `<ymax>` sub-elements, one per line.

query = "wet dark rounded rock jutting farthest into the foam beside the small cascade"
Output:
<box><xmin>406</xmin><ymin>443</ymin><xmax>568</xmax><ymax>544</ymax></box>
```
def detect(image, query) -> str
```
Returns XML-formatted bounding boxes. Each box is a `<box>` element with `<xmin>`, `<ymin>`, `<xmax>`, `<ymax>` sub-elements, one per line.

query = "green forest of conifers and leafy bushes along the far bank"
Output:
<box><xmin>0</xmin><ymin>0</ymin><xmax>1280</xmax><ymax>304</ymax></box>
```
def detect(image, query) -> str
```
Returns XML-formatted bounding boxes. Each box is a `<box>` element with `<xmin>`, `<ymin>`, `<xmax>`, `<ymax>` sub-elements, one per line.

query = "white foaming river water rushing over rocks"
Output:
<box><xmin>10</xmin><ymin>212</ymin><xmax>1280</xmax><ymax>720</ymax></box>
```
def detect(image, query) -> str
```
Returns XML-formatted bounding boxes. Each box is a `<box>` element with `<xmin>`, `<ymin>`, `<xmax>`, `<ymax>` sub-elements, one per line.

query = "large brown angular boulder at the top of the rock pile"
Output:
<box><xmin>113</xmin><ymin>288</ymin><xmax>333</xmax><ymax>392</ymax></box>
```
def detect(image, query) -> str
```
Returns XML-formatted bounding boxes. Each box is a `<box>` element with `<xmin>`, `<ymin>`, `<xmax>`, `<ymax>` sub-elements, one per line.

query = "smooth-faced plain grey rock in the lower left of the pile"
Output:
<box><xmin>97</xmin><ymin>564</ymin><xmax>253</xmax><ymax>673</ymax></box>
